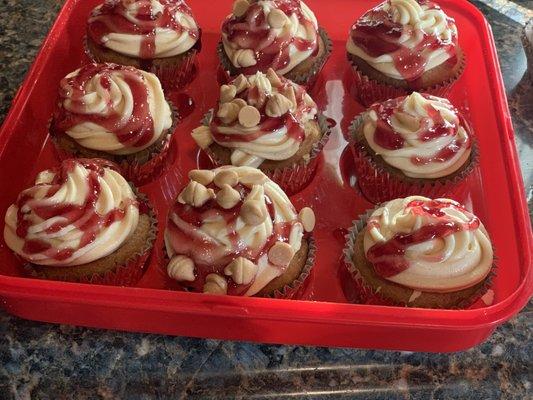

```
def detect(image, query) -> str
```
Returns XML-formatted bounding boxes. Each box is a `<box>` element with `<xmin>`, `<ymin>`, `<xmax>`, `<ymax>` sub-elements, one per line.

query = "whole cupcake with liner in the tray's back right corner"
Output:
<box><xmin>346</xmin><ymin>0</ymin><xmax>465</xmax><ymax>105</ymax></box>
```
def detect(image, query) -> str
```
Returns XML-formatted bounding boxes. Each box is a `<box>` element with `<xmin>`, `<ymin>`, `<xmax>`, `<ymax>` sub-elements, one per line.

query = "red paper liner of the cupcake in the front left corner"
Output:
<box><xmin>23</xmin><ymin>192</ymin><xmax>157</xmax><ymax>286</ymax></box>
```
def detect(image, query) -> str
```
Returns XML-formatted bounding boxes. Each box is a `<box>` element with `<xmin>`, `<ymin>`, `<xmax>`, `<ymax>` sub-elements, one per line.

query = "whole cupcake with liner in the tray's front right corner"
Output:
<box><xmin>345</xmin><ymin>196</ymin><xmax>494</xmax><ymax>308</ymax></box>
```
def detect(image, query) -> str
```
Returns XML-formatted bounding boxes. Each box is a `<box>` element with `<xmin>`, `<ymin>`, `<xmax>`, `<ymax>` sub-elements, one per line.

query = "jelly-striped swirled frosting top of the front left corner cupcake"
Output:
<box><xmin>4</xmin><ymin>159</ymin><xmax>139</xmax><ymax>266</ymax></box>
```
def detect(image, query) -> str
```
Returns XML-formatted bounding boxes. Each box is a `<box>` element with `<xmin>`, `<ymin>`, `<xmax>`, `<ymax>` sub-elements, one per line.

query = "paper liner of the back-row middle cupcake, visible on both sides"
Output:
<box><xmin>217</xmin><ymin>28</ymin><xmax>333</xmax><ymax>89</ymax></box>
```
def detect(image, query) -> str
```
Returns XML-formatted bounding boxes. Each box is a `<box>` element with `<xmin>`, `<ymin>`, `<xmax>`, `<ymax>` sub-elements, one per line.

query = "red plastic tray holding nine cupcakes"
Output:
<box><xmin>0</xmin><ymin>0</ymin><xmax>533</xmax><ymax>351</ymax></box>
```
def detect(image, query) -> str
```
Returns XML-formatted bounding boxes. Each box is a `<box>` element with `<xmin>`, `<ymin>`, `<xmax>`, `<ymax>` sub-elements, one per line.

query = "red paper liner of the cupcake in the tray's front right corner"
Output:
<box><xmin>342</xmin><ymin>206</ymin><xmax>497</xmax><ymax>309</ymax></box>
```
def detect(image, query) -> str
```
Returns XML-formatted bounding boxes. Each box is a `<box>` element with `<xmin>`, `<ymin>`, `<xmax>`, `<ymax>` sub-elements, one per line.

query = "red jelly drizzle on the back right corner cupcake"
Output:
<box><xmin>350</xmin><ymin>0</ymin><xmax>457</xmax><ymax>83</ymax></box>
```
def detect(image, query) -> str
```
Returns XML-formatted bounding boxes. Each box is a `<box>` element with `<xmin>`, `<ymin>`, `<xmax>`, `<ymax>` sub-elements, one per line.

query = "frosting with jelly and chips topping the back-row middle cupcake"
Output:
<box><xmin>222</xmin><ymin>0</ymin><xmax>318</xmax><ymax>75</ymax></box>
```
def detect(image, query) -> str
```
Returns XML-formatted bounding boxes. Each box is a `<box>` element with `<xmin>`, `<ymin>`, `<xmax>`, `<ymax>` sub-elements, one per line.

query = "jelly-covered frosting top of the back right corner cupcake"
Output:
<box><xmin>346</xmin><ymin>0</ymin><xmax>458</xmax><ymax>81</ymax></box>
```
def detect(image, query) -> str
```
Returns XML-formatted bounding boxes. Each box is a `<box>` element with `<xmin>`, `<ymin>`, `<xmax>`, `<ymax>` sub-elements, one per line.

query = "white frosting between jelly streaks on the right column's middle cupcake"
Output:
<box><xmin>363</xmin><ymin>92</ymin><xmax>472</xmax><ymax>179</ymax></box>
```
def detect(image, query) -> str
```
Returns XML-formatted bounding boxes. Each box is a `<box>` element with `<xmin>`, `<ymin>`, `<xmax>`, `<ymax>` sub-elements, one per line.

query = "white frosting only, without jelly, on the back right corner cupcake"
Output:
<box><xmin>346</xmin><ymin>0</ymin><xmax>457</xmax><ymax>80</ymax></box>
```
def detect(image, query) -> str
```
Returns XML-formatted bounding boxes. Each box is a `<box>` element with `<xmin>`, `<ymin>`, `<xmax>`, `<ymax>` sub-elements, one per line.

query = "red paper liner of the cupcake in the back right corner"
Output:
<box><xmin>348</xmin><ymin>54</ymin><xmax>466</xmax><ymax>107</ymax></box>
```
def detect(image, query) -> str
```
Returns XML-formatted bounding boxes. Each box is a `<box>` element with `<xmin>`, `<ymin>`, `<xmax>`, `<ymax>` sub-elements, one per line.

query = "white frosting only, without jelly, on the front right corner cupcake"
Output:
<box><xmin>364</xmin><ymin>196</ymin><xmax>493</xmax><ymax>293</ymax></box>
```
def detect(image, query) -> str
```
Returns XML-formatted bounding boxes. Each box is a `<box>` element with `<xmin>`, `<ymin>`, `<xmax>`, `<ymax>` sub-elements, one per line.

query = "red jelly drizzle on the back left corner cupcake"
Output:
<box><xmin>87</xmin><ymin>0</ymin><xmax>199</xmax><ymax>59</ymax></box>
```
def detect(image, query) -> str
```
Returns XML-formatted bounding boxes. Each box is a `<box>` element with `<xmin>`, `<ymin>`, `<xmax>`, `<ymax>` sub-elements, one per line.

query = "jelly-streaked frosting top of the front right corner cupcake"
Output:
<box><xmin>364</xmin><ymin>196</ymin><xmax>493</xmax><ymax>293</ymax></box>
